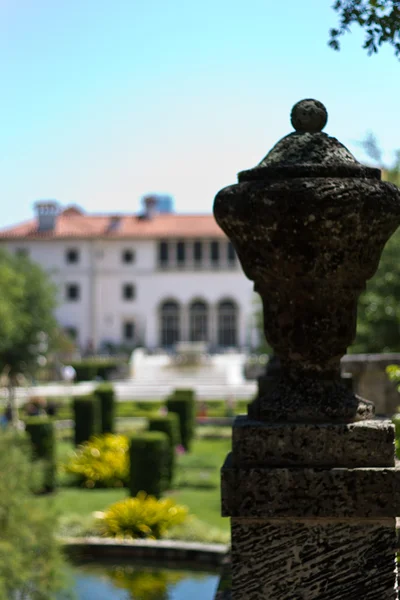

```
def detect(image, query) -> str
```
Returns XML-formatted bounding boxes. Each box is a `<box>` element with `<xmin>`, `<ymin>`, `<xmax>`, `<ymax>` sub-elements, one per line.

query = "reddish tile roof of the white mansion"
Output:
<box><xmin>0</xmin><ymin>207</ymin><xmax>225</xmax><ymax>240</ymax></box>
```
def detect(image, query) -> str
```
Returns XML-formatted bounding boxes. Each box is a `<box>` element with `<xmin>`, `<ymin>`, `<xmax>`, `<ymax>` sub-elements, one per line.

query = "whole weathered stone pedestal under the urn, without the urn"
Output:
<box><xmin>222</xmin><ymin>417</ymin><xmax>400</xmax><ymax>600</ymax></box>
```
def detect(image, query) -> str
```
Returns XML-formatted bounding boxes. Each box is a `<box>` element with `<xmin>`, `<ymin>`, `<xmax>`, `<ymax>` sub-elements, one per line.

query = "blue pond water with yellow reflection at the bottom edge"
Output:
<box><xmin>67</xmin><ymin>565</ymin><xmax>219</xmax><ymax>600</ymax></box>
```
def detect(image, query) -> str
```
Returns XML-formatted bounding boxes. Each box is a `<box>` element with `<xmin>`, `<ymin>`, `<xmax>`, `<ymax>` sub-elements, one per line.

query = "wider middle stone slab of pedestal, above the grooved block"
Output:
<box><xmin>221</xmin><ymin>455</ymin><xmax>400</xmax><ymax>518</ymax></box>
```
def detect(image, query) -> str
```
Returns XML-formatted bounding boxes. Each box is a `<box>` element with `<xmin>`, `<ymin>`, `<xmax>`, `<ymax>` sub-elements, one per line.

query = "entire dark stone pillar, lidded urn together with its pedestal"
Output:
<box><xmin>214</xmin><ymin>100</ymin><xmax>400</xmax><ymax>600</ymax></box>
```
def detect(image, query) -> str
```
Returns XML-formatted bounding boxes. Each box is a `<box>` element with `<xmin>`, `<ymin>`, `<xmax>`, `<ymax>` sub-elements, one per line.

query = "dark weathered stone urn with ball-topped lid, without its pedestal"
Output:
<box><xmin>214</xmin><ymin>99</ymin><xmax>400</xmax><ymax>422</ymax></box>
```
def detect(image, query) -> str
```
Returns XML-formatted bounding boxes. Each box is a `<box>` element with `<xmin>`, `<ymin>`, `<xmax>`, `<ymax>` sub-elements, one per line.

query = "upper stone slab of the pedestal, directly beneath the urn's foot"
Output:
<box><xmin>232</xmin><ymin>416</ymin><xmax>395</xmax><ymax>468</ymax></box>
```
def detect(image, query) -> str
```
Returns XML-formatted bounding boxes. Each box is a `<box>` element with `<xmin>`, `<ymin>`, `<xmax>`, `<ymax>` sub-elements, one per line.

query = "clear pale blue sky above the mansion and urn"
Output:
<box><xmin>0</xmin><ymin>0</ymin><xmax>400</xmax><ymax>226</ymax></box>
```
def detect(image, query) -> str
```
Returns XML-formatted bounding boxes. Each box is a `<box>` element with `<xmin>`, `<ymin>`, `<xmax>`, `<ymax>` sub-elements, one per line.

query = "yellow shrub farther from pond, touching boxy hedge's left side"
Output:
<box><xmin>64</xmin><ymin>433</ymin><xmax>129</xmax><ymax>488</ymax></box>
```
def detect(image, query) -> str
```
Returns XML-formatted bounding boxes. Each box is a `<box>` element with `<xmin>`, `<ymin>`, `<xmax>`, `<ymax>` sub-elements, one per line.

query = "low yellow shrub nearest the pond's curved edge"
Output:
<box><xmin>101</xmin><ymin>492</ymin><xmax>188</xmax><ymax>539</ymax></box>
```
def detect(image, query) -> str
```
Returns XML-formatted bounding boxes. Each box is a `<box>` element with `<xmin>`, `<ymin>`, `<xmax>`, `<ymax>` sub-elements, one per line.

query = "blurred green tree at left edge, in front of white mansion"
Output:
<box><xmin>0</xmin><ymin>251</ymin><xmax>57</xmax><ymax>378</ymax></box>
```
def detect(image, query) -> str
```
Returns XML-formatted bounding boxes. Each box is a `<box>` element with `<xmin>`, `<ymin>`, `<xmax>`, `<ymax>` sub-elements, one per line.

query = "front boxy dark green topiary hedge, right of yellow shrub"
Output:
<box><xmin>129</xmin><ymin>431</ymin><xmax>169</xmax><ymax>497</ymax></box>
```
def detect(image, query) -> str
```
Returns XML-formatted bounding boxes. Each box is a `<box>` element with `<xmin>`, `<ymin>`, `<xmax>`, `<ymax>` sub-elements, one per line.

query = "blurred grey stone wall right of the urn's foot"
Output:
<box><xmin>341</xmin><ymin>353</ymin><xmax>400</xmax><ymax>416</ymax></box>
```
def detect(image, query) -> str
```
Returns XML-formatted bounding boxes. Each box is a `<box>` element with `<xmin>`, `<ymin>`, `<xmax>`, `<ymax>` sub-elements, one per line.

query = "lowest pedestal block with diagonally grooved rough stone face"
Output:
<box><xmin>232</xmin><ymin>519</ymin><xmax>397</xmax><ymax>600</ymax></box>
